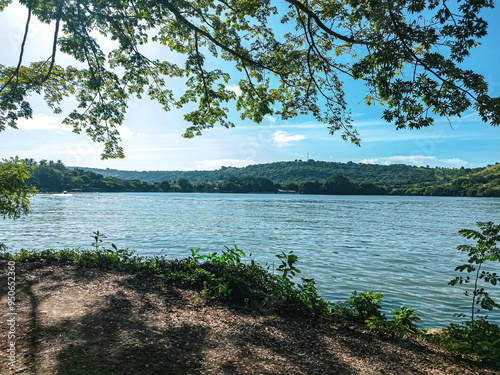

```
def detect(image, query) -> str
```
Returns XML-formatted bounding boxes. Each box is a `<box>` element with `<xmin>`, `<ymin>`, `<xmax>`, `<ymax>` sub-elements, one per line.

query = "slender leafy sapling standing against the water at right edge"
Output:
<box><xmin>448</xmin><ymin>221</ymin><xmax>500</xmax><ymax>321</ymax></box>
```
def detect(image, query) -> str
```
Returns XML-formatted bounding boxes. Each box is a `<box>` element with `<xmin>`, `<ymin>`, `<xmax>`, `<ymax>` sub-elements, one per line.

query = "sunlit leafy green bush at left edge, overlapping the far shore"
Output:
<box><xmin>0</xmin><ymin>158</ymin><xmax>36</xmax><ymax>219</ymax></box>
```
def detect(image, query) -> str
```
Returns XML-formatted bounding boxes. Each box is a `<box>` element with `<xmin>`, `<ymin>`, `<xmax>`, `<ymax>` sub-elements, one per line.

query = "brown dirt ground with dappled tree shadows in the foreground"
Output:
<box><xmin>0</xmin><ymin>262</ymin><xmax>498</xmax><ymax>375</ymax></box>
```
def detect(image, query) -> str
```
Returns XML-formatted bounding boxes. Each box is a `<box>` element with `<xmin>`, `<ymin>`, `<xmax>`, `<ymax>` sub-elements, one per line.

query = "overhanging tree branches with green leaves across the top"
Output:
<box><xmin>0</xmin><ymin>0</ymin><xmax>500</xmax><ymax>158</ymax></box>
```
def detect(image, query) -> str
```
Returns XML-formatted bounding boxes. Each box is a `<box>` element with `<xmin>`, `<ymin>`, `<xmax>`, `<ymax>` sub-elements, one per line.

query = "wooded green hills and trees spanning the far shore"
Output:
<box><xmin>18</xmin><ymin>159</ymin><xmax>500</xmax><ymax>197</ymax></box>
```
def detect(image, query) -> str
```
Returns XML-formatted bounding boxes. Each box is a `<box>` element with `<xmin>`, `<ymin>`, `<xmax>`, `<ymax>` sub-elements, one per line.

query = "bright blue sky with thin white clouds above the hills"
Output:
<box><xmin>0</xmin><ymin>4</ymin><xmax>500</xmax><ymax>170</ymax></box>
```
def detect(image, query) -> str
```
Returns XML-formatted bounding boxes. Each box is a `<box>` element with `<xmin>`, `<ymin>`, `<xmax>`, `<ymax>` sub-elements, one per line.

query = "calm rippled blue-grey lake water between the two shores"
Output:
<box><xmin>0</xmin><ymin>193</ymin><xmax>500</xmax><ymax>327</ymax></box>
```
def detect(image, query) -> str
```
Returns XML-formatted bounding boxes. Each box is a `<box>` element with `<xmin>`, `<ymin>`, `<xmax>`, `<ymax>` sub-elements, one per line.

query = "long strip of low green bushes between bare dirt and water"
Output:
<box><xmin>0</xmin><ymin>245</ymin><xmax>419</xmax><ymax>335</ymax></box>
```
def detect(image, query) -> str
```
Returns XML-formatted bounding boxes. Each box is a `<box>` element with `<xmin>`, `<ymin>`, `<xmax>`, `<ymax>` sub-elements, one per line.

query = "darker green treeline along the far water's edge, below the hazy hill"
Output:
<box><xmin>20</xmin><ymin>159</ymin><xmax>500</xmax><ymax>197</ymax></box>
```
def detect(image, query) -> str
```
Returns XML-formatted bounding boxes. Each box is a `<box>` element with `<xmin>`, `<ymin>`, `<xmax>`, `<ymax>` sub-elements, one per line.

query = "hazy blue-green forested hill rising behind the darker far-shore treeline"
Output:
<box><xmin>71</xmin><ymin>160</ymin><xmax>488</xmax><ymax>189</ymax></box>
